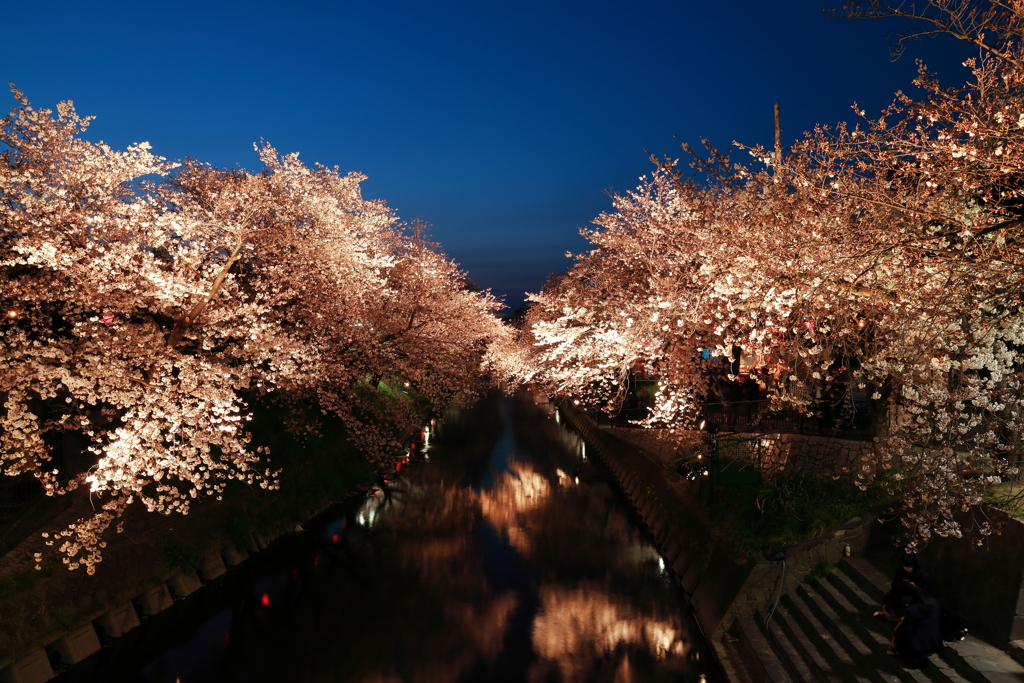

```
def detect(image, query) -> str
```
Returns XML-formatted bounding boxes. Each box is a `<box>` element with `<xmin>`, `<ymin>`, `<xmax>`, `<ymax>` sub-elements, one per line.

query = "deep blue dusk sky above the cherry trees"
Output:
<box><xmin>0</xmin><ymin>0</ymin><xmax>971</xmax><ymax>308</ymax></box>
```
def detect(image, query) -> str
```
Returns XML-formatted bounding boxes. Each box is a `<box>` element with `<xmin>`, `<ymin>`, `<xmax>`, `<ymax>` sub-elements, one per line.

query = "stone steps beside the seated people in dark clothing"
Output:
<box><xmin>722</xmin><ymin>557</ymin><xmax>1024</xmax><ymax>683</ymax></box>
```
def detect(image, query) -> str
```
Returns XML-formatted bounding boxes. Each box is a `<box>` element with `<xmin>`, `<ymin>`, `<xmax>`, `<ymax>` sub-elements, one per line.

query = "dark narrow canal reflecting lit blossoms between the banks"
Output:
<box><xmin>63</xmin><ymin>395</ymin><xmax>721</xmax><ymax>683</ymax></box>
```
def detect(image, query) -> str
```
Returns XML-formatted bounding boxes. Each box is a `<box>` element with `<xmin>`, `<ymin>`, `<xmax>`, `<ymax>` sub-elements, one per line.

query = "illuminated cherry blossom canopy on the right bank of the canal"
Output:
<box><xmin>491</xmin><ymin>2</ymin><xmax>1024</xmax><ymax>548</ymax></box>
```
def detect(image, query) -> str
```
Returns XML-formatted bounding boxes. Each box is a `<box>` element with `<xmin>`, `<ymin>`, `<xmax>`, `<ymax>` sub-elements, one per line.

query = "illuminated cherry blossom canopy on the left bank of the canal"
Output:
<box><xmin>0</xmin><ymin>88</ymin><xmax>507</xmax><ymax>573</ymax></box>
